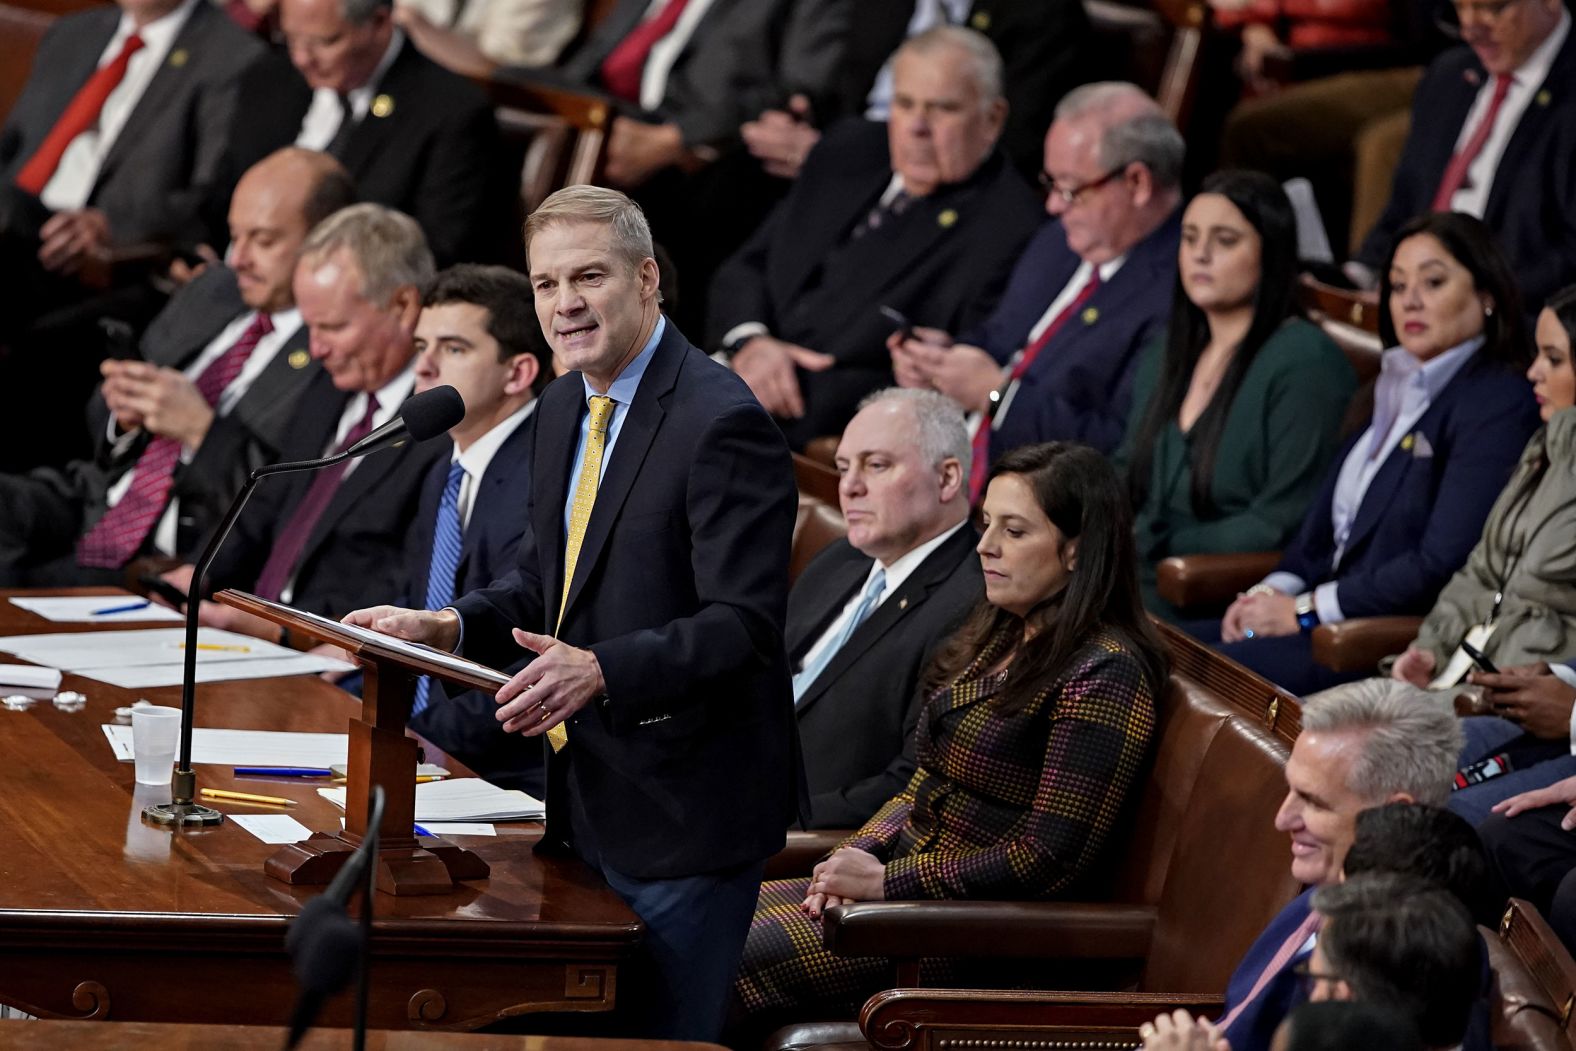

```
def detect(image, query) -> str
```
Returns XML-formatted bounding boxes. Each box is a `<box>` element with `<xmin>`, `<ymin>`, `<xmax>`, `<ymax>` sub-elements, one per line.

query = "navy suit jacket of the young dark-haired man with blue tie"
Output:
<box><xmin>405</xmin><ymin>419</ymin><xmax>547</xmax><ymax>797</ymax></box>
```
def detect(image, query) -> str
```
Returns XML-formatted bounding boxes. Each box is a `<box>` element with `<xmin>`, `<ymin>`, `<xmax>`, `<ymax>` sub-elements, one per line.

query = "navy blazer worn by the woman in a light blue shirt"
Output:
<box><xmin>1278</xmin><ymin>355</ymin><xmax>1540</xmax><ymax>618</ymax></box>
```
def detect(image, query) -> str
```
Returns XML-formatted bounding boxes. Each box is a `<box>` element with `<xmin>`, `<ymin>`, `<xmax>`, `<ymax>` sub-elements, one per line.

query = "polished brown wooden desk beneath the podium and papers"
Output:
<box><xmin>0</xmin><ymin>591</ymin><xmax>640</xmax><ymax>1029</ymax></box>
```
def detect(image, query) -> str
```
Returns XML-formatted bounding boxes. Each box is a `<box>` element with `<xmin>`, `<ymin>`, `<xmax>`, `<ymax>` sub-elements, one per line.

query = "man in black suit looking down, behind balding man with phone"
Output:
<box><xmin>230</xmin><ymin>0</ymin><xmax>519</xmax><ymax>266</ymax></box>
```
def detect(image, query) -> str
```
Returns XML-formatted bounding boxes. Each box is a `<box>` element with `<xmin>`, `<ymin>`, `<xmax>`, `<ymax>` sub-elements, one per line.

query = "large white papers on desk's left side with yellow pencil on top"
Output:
<box><xmin>0</xmin><ymin>627</ymin><xmax>353</xmax><ymax>690</ymax></box>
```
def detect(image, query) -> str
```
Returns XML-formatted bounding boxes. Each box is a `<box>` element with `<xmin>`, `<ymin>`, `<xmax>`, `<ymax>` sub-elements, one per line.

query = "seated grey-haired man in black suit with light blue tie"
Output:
<box><xmin>786</xmin><ymin>388</ymin><xmax>983</xmax><ymax>829</ymax></box>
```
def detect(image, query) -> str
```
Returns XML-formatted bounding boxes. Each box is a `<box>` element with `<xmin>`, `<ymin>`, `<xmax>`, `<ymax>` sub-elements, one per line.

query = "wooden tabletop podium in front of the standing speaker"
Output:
<box><xmin>214</xmin><ymin>589</ymin><xmax>509</xmax><ymax>895</ymax></box>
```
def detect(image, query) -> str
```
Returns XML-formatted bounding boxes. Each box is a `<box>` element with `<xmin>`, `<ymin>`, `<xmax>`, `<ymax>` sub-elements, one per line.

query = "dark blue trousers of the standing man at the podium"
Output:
<box><xmin>567</xmin><ymin>756</ymin><xmax>766</xmax><ymax>1042</ymax></box>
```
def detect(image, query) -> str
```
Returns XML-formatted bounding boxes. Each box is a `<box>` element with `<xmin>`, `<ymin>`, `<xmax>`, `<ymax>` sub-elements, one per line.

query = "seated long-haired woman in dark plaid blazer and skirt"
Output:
<box><xmin>736</xmin><ymin>443</ymin><xmax>1165</xmax><ymax>1023</ymax></box>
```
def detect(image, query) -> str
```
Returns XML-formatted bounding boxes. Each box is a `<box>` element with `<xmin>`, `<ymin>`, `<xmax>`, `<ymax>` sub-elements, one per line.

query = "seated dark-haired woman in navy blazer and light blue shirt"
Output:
<box><xmin>1188</xmin><ymin>213</ymin><xmax>1538</xmax><ymax>693</ymax></box>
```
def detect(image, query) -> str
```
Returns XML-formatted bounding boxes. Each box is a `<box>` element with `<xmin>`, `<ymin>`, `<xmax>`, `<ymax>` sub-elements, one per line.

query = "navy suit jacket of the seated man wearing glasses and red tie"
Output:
<box><xmin>960</xmin><ymin>211</ymin><xmax>1182</xmax><ymax>460</ymax></box>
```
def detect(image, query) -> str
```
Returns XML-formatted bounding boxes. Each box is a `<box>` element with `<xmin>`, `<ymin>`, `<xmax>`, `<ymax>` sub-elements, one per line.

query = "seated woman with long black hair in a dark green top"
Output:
<box><xmin>1117</xmin><ymin>172</ymin><xmax>1357</xmax><ymax>618</ymax></box>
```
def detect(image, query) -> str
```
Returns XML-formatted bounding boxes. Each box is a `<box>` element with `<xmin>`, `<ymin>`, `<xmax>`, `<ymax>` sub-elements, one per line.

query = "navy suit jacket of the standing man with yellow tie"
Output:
<box><xmin>455</xmin><ymin>320</ymin><xmax>801</xmax><ymax>879</ymax></box>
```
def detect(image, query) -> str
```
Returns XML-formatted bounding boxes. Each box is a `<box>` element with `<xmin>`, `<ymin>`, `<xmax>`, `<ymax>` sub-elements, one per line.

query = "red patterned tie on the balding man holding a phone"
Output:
<box><xmin>77</xmin><ymin>314</ymin><xmax>274</xmax><ymax>569</ymax></box>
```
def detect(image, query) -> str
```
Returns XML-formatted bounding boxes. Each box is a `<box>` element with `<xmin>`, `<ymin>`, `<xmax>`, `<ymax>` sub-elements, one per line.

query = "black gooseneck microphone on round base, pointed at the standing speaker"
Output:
<box><xmin>142</xmin><ymin>384</ymin><xmax>465</xmax><ymax>826</ymax></box>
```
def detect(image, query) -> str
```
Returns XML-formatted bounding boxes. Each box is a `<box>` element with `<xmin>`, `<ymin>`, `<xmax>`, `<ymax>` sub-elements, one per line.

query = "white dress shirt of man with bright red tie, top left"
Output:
<box><xmin>38</xmin><ymin>0</ymin><xmax>199</xmax><ymax>211</ymax></box>
